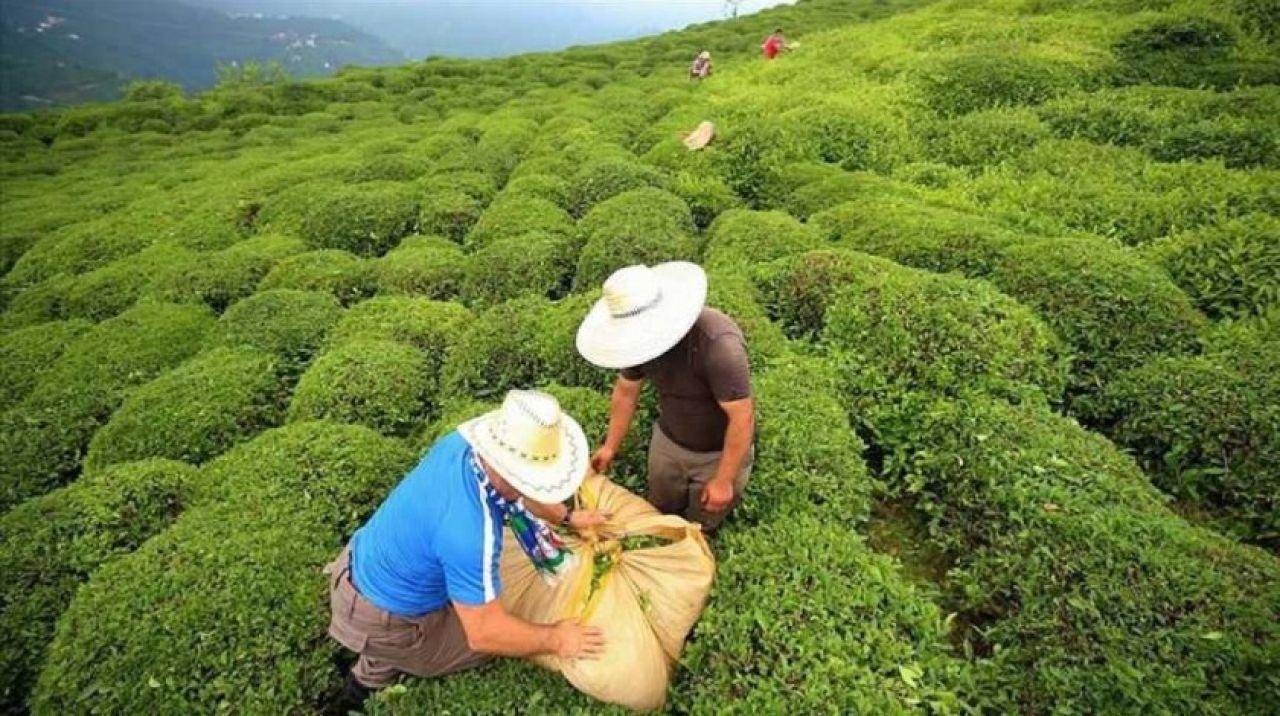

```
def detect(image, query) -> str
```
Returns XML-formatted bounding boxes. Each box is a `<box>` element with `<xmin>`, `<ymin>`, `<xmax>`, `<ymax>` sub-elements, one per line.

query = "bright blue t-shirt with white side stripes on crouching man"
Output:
<box><xmin>351</xmin><ymin>432</ymin><xmax>502</xmax><ymax>616</ymax></box>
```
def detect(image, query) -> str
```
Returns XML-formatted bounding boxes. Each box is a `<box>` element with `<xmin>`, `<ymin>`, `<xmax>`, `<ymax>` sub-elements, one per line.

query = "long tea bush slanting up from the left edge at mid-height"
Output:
<box><xmin>0</xmin><ymin>304</ymin><xmax>214</xmax><ymax>507</ymax></box>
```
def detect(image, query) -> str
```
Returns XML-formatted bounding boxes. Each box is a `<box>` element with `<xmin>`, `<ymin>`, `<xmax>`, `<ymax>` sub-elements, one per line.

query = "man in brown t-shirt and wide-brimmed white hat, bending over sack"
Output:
<box><xmin>577</xmin><ymin>261</ymin><xmax>755</xmax><ymax>533</ymax></box>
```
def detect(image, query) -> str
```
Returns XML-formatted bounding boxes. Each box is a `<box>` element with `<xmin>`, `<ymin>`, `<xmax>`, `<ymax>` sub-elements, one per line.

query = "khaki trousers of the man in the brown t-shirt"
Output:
<box><xmin>648</xmin><ymin>423</ymin><xmax>755</xmax><ymax>533</ymax></box>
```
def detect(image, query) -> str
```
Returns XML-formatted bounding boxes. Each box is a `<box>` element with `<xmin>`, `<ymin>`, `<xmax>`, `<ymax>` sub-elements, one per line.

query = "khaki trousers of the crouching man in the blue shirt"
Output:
<box><xmin>324</xmin><ymin>546</ymin><xmax>489</xmax><ymax>688</ymax></box>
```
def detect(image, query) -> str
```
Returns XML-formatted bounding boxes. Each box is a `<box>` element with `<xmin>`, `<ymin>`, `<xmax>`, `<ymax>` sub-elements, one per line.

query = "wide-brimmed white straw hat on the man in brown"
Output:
<box><xmin>577</xmin><ymin>261</ymin><xmax>707</xmax><ymax>369</ymax></box>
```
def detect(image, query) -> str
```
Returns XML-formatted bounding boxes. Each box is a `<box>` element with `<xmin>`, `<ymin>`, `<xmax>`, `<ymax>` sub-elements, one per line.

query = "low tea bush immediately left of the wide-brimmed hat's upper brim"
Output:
<box><xmin>460</xmin><ymin>232</ymin><xmax>579</xmax><ymax>307</ymax></box>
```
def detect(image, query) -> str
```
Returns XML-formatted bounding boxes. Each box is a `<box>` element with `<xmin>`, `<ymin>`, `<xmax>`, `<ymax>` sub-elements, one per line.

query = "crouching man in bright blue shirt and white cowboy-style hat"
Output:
<box><xmin>325</xmin><ymin>391</ymin><xmax>607</xmax><ymax>707</ymax></box>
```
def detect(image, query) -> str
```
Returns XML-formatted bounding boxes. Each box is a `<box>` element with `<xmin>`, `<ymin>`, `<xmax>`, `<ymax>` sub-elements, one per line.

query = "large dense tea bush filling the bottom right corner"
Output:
<box><xmin>880</xmin><ymin>398</ymin><xmax>1280</xmax><ymax>713</ymax></box>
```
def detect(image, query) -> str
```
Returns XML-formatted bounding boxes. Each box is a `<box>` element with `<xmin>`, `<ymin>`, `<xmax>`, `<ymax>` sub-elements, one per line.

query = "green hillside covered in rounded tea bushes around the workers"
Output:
<box><xmin>0</xmin><ymin>0</ymin><xmax>1280</xmax><ymax>715</ymax></box>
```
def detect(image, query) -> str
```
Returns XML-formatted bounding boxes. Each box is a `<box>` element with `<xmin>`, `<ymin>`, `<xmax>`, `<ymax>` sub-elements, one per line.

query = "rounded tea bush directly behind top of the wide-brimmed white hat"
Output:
<box><xmin>573</xmin><ymin>187</ymin><xmax>698</xmax><ymax>291</ymax></box>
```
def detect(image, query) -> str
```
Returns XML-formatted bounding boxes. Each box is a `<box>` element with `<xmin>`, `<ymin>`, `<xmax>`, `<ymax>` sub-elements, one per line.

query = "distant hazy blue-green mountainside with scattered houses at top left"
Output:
<box><xmin>0</xmin><ymin>0</ymin><xmax>403</xmax><ymax>111</ymax></box>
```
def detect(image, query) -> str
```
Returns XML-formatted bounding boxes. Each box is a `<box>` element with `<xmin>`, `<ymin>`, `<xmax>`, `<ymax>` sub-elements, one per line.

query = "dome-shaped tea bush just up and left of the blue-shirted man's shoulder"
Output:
<box><xmin>289</xmin><ymin>338</ymin><xmax>435</xmax><ymax>435</ymax></box>
